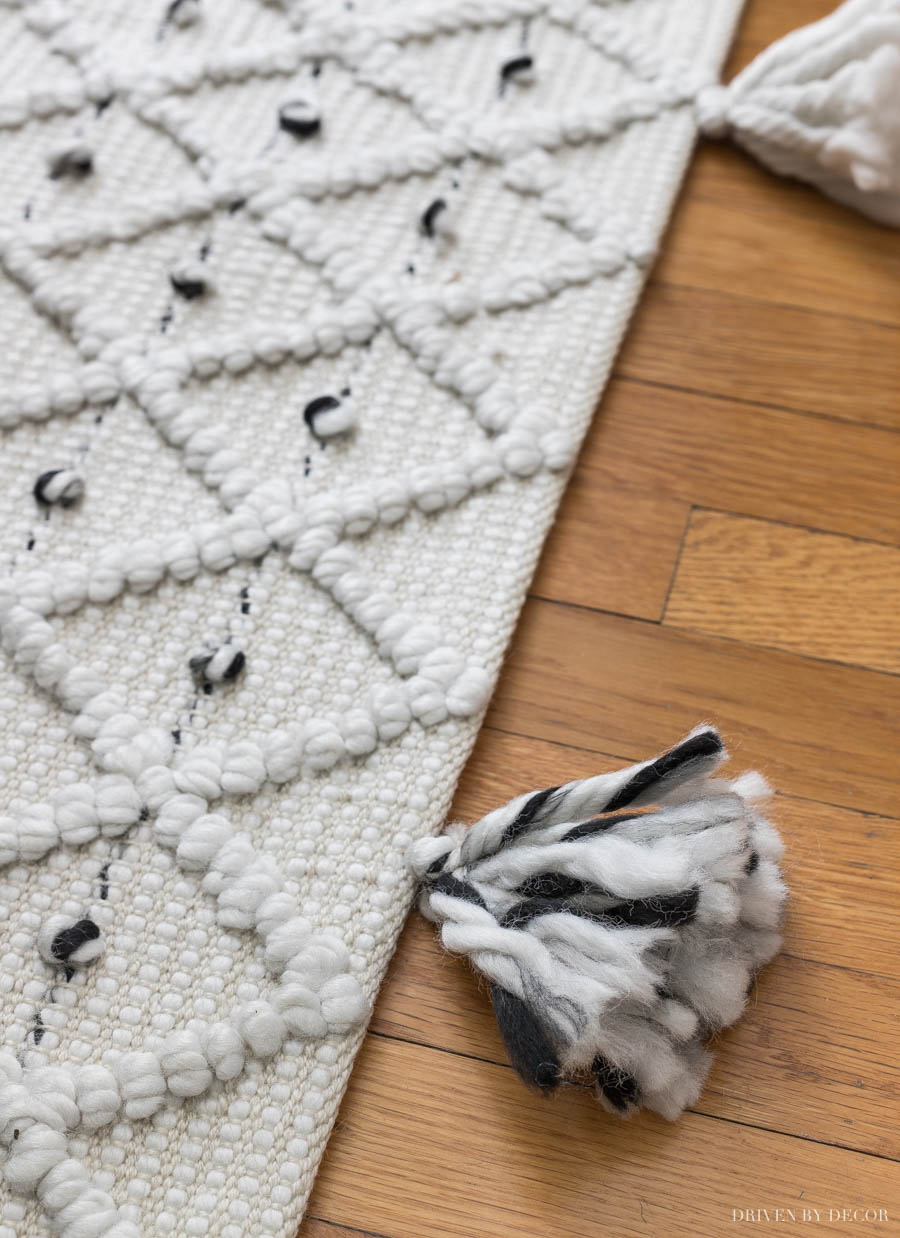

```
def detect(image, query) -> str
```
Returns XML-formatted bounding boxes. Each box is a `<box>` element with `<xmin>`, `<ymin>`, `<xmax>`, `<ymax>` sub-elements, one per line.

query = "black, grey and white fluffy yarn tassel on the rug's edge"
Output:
<box><xmin>410</xmin><ymin>727</ymin><xmax>786</xmax><ymax>1119</ymax></box>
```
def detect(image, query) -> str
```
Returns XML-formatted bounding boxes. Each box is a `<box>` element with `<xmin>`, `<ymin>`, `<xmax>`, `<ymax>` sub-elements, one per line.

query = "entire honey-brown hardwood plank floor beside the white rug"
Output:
<box><xmin>301</xmin><ymin>0</ymin><xmax>900</xmax><ymax>1238</ymax></box>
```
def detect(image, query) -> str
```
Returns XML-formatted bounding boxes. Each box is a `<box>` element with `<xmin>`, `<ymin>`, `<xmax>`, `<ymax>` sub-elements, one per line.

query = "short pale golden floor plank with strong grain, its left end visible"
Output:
<box><xmin>665</xmin><ymin>511</ymin><xmax>900</xmax><ymax>673</ymax></box>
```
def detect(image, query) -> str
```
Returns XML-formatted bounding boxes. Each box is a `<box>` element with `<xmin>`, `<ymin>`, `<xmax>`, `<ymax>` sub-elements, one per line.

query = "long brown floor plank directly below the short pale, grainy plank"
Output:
<box><xmin>488</xmin><ymin>599</ymin><xmax>900</xmax><ymax>817</ymax></box>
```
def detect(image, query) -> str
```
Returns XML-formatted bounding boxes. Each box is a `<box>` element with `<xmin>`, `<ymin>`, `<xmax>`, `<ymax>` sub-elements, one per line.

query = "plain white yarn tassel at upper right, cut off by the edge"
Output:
<box><xmin>696</xmin><ymin>0</ymin><xmax>900</xmax><ymax>228</ymax></box>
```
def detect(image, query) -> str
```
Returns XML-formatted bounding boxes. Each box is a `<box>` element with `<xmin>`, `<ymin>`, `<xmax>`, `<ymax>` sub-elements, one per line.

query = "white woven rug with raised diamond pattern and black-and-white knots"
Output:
<box><xmin>0</xmin><ymin>0</ymin><xmax>739</xmax><ymax>1238</ymax></box>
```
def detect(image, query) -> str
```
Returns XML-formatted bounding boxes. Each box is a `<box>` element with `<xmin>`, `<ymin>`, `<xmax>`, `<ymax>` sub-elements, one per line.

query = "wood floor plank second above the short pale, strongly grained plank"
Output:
<box><xmin>615</xmin><ymin>280</ymin><xmax>900</xmax><ymax>430</ymax></box>
